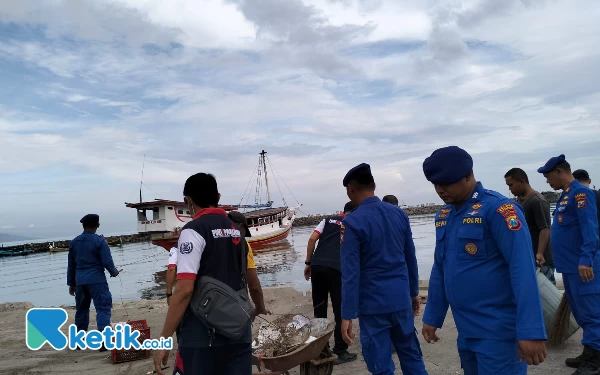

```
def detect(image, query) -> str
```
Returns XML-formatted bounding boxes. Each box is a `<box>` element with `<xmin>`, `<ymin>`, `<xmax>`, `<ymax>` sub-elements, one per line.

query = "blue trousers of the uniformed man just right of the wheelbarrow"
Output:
<box><xmin>358</xmin><ymin>309</ymin><xmax>427</xmax><ymax>375</ymax></box>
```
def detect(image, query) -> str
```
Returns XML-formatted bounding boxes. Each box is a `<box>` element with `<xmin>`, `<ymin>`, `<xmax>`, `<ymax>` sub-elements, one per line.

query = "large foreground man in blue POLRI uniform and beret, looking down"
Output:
<box><xmin>423</xmin><ymin>146</ymin><xmax>546</xmax><ymax>375</ymax></box>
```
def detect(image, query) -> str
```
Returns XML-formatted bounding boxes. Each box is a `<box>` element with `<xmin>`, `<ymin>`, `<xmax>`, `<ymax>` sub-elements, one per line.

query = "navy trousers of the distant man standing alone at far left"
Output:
<box><xmin>75</xmin><ymin>282</ymin><xmax>112</xmax><ymax>332</ymax></box>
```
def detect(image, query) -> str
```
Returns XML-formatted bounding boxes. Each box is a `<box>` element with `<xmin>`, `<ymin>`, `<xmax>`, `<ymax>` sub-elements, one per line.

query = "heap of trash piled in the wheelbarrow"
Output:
<box><xmin>252</xmin><ymin>314</ymin><xmax>329</xmax><ymax>357</ymax></box>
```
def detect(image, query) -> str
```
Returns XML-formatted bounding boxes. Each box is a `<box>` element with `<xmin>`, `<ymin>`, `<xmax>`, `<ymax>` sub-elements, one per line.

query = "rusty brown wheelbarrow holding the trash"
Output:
<box><xmin>252</xmin><ymin>323</ymin><xmax>337</xmax><ymax>375</ymax></box>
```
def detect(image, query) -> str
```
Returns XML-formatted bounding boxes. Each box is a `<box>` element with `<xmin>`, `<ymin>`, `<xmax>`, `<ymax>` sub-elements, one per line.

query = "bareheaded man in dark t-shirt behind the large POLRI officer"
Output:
<box><xmin>504</xmin><ymin>168</ymin><xmax>556</xmax><ymax>285</ymax></box>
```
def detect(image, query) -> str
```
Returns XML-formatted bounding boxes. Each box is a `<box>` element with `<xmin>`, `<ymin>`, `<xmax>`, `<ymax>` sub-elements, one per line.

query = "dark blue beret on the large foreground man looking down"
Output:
<box><xmin>423</xmin><ymin>146</ymin><xmax>473</xmax><ymax>185</ymax></box>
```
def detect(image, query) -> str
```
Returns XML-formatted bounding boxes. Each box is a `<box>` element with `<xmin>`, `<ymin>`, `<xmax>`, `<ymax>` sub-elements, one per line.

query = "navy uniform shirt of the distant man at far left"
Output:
<box><xmin>67</xmin><ymin>232</ymin><xmax>117</xmax><ymax>287</ymax></box>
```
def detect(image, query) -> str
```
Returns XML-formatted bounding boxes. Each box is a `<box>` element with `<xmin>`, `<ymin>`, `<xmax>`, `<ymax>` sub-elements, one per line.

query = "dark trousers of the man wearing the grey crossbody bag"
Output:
<box><xmin>178</xmin><ymin>344</ymin><xmax>252</xmax><ymax>375</ymax></box>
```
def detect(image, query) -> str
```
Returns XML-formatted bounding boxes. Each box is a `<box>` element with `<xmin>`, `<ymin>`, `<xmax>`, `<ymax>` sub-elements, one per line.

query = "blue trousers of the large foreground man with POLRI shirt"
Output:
<box><xmin>457</xmin><ymin>335</ymin><xmax>527</xmax><ymax>375</ymax></box>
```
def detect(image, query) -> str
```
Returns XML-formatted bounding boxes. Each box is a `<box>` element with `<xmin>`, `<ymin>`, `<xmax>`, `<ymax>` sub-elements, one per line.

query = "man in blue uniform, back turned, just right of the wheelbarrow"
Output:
<box><xmin>340</xmin><ymin>163</ymin><xmax>427</xmax><ymax>375</ymax></box>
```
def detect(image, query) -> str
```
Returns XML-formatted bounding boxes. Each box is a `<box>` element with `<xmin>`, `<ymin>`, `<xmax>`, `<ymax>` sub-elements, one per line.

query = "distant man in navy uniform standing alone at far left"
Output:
<box><xmin>67</xmin><ymin>214</ymin><xmax>119</xmax><ymax>351</ymax></box>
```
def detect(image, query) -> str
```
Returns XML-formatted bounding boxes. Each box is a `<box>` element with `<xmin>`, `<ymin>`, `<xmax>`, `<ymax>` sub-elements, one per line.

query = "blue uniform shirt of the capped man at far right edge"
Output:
<box><xmin>550</xmin><ymin>180</ymin><xmax>598</xmax><ymax>273</ymax></box>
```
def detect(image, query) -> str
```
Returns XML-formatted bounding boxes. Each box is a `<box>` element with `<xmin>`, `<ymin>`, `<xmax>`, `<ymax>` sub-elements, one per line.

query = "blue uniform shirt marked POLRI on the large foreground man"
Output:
<box><xmin>423</xmin><ymin>183</ymin><xmax>546</xmax><ymax>340</ymax></box>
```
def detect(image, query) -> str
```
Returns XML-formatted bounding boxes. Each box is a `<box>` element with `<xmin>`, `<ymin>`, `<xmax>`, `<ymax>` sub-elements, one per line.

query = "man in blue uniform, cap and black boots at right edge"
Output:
<box><xmin>538</xmin><ymin>155</ymin><xmax>600</xmax><ymax>375</ymax></box>
